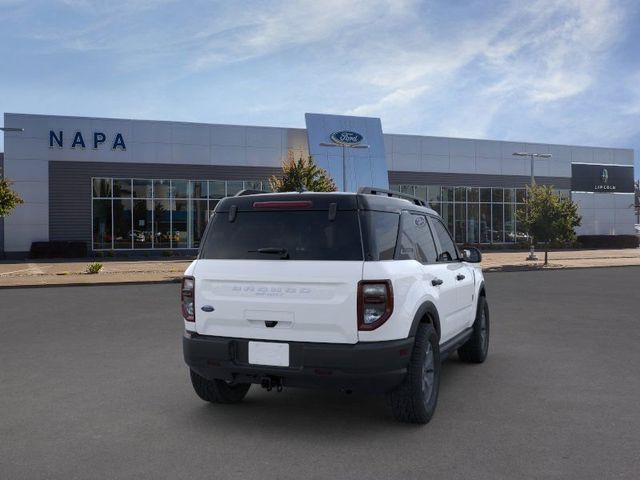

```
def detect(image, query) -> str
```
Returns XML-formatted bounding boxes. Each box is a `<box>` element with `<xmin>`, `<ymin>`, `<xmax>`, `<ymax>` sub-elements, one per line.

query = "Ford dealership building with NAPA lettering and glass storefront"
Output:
<box><xmin>0</xmin><ymin>113</ymin><xmax>635</xmax><ymax>258</ymax></box>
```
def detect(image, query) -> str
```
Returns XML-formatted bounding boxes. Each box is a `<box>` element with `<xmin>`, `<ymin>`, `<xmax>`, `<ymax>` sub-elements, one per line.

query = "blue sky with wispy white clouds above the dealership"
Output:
<box><xmin>0</xmin><ymin>0</ymin><xmax>640</xmax><ymax>176</ymax></box>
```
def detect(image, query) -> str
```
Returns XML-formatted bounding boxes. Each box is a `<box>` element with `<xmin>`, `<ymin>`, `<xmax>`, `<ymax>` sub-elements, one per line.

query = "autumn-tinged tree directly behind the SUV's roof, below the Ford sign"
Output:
<box><xmin>269</xmin><ymin>151</ymin><xmax>336</xmax><ymax>192</ymax></box>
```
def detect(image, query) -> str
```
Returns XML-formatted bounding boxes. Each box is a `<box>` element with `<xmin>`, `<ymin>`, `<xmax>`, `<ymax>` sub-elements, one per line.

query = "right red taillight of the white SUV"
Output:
<box><xmin>358</xmin><ymin>280</ymin><xmax>393</xmax><ymax>330</ymax></box>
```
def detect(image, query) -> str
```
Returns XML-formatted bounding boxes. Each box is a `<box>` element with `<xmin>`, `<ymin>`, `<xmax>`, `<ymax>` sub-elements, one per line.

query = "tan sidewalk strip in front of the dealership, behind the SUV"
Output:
<box><xmin>0</xmin><ymin>248</ymin><xmax>640</xmax><ymax>288</ymax></box>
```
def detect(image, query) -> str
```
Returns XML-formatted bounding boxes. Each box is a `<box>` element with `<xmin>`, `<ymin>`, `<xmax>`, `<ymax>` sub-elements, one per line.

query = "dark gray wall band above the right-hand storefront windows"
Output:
<box><xmin>389</xmin><ymin>171</ymin><xmax>571</xmax><ymax>190</ymax></box>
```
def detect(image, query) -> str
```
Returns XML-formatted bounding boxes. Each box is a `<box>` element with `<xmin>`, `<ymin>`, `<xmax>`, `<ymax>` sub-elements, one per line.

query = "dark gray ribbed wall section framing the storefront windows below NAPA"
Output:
<box><xmin>49</xmin><ymin>162</ymin><xmax>281</xmax><ymax>245</ymax></box>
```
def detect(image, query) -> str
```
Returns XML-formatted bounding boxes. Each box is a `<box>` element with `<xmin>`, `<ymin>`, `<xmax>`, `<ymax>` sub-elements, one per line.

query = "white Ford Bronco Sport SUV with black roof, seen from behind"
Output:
<box><xmin>182</xmin><ymin>189</ymin><xmax>489</xmax><ymax>423</ymax></box>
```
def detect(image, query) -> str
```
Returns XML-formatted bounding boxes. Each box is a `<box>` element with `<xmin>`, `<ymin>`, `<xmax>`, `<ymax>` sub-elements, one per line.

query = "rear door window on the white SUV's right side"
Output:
<box><xmin>396</xmin><ymin>213</ymin><xmax>437</xmax><ymax>263</ymax></box>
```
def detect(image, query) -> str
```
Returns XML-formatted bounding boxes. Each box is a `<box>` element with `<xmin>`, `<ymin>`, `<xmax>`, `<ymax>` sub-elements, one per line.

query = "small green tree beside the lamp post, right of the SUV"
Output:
<box><xmin>518</xmin><ymin>185</ymin><xmax>582</xmax><ymax>265</ymax></box>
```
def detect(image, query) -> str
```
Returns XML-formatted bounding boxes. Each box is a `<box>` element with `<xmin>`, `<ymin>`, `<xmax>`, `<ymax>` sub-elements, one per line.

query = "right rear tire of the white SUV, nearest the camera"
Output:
<box><xmin>387</xmin><ymin>323</ymin><xmax>441</xmax><ymax>424</ymax></box>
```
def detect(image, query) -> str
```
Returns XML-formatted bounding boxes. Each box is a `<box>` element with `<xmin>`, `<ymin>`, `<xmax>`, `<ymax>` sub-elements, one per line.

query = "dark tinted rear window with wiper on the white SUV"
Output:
<box><xmin>200</xmin><ymin>210</ymin><xmax>363</xmax><ymax>260</ymax></box>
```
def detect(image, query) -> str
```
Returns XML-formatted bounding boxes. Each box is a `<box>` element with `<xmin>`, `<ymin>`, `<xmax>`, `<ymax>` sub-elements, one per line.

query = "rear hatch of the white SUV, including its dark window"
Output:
<box><xmin>194</xmin><ymin>194</ymin><xmax>363</xmax><ymax>343</ymax></box>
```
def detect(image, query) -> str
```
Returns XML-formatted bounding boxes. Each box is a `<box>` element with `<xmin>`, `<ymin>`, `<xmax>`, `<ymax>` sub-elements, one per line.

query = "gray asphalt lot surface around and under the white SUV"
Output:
<box><xmin>0</xmin><ymin>267</ymin><xmax>640</xmax><ymax>480</ymax></box>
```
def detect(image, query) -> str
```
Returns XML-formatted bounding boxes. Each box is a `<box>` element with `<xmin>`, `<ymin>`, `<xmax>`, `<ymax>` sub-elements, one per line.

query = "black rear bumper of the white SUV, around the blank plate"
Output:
<box><xmin>182</xmin><ymin>332</ymin><xmax>414</xmax><ymax>392</ymax></box>
